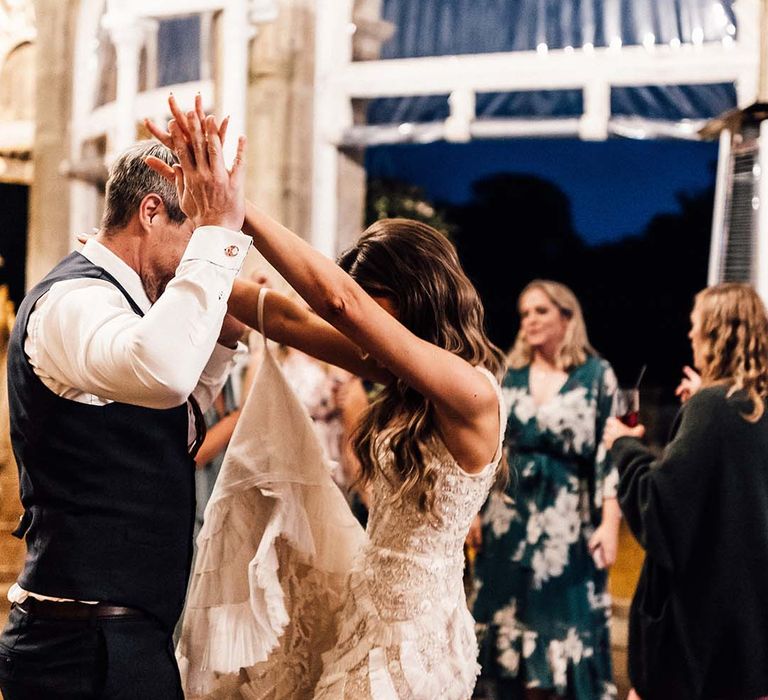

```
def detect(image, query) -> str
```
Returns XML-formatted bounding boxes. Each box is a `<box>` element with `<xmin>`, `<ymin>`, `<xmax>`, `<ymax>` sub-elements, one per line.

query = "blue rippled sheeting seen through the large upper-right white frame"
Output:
<box><xmin>368</xmin><ymin>0</ymin><xmax>737</xmax><ymax>125</ymax></box>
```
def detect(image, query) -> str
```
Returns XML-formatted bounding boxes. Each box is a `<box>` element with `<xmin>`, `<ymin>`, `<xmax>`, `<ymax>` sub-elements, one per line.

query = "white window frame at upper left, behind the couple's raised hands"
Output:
<box><xmin>70</xmin><ymin>0</ymin><xmax>277</xmax><ymax>237</ymax></box>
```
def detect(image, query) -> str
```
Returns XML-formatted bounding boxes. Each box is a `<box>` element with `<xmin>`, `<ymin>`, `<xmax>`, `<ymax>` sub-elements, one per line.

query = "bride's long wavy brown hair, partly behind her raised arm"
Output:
<box><xmin>338</xmin><ymin>219</ymin><xmax>506</xmax><ymax>514</ymax></box>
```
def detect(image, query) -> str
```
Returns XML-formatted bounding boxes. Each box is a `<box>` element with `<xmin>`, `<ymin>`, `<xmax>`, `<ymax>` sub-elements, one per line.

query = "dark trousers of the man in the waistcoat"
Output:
<box><xmin>0</xmin><ymin>605</ymin><xmax>184</xmax><ymax>700</ymax></box>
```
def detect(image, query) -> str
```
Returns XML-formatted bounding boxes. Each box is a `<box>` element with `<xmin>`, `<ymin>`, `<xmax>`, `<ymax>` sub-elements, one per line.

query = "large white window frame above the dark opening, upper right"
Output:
<box><xmin>311</xmin><ymin>0</ymin><xmax>760</xmax><ymax>255</ymax></box>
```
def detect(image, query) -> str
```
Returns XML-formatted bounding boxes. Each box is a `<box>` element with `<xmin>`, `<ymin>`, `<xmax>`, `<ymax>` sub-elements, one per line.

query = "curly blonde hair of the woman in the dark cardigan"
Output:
<box><xmin>693</xmin><ymin>282</ymin><xmax>768</xmax><ymax>422</ymax></box>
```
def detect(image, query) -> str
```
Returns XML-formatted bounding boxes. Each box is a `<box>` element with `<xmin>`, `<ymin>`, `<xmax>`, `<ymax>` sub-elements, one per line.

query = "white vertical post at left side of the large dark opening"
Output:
<box><xmin>310</xmin><ymin>0</ymin><xmax>355</xmax><ymax>257</ymax></box>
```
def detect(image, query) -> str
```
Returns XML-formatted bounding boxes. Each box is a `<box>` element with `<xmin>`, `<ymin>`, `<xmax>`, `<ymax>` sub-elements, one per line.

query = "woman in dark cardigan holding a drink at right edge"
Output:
<box><xmin>604</xmin><ymin>283</ymin><xmax>768</xmax><ymax>700</ymax></box>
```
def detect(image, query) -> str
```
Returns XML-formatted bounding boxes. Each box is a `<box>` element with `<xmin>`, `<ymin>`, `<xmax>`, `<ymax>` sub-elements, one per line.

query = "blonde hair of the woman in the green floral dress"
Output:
<box><xmin>507</xmin><ymin>280</ymin><xmax>597</xmax><ymax>370</ymax></box>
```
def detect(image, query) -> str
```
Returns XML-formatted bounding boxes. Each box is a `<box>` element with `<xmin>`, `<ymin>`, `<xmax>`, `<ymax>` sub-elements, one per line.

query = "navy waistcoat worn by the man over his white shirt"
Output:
<box><xmin>8</xmin><ymin>253</ymin><xmax>195</xmax><ymax>630</ymax></box>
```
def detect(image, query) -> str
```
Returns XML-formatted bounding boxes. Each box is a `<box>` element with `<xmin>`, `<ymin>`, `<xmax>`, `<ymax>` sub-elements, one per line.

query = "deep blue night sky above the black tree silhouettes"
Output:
<box><xmin>366</xmin><ymin>139</ymin><xmax>717</xmax><ymax>244</ymax></box>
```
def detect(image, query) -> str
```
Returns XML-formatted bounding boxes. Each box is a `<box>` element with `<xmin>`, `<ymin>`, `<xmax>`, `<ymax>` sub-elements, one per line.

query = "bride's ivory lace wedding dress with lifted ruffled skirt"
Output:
<box><xmin>177</xmin><ymin>296</ymin><xmax>504</xmax><ymax>700</ymax></box>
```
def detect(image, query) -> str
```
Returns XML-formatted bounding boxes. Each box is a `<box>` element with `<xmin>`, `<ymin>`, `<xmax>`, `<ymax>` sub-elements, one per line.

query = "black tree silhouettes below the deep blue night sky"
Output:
<box><xmin>368</xmin><ymin>173</ymin><xmax>714</xmax><ymax>394</ymax></box>
